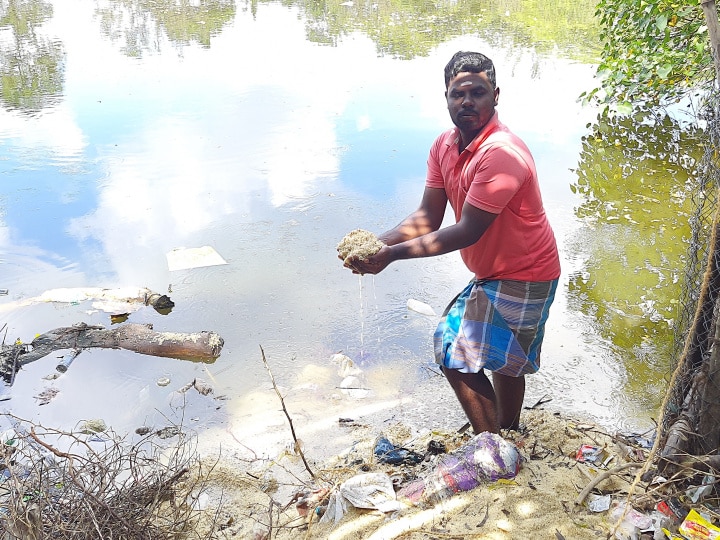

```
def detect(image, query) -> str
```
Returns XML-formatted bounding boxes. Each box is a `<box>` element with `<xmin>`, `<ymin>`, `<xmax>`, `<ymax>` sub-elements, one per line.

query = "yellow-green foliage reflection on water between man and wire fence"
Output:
<box><xmin>568</xmin><ymin>109</ymin><xmax>703</xmax><ymax>414</ymax></box>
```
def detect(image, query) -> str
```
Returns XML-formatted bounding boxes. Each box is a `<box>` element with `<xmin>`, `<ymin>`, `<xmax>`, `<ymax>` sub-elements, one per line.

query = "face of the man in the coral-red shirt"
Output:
<box><xmin>445</xmin><ymin>72</ymin><xmax>500</xmax><ymax>138</ymax></box>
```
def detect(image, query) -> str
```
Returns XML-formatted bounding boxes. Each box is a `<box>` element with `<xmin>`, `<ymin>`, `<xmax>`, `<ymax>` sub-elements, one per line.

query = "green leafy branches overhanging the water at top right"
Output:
<box><xmin>583</xmin><ymin>0</ymin><xmax>715</xmax><ymax>109</ymax></box>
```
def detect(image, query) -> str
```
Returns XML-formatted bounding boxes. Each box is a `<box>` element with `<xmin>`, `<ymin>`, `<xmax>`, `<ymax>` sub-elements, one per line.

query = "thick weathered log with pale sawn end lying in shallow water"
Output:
<box><xmin>0</xmin><ymin>323</ymin><xmax>224</xmax><ymax>383</ymax></box>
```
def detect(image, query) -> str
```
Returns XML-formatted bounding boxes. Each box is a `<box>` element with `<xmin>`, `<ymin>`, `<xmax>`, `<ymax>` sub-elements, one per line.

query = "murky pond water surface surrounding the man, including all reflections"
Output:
<box><xmin>0</xmin><ymin>0</ymin><xmax>696</xmax><ymax>458</ymax></box>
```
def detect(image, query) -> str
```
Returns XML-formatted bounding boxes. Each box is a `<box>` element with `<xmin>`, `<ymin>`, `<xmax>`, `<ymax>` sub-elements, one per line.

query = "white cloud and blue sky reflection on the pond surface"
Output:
<box><xmin>0</xmin><ymin>1</ymin><xmax>660</xmax><ymax>448</ymax></box>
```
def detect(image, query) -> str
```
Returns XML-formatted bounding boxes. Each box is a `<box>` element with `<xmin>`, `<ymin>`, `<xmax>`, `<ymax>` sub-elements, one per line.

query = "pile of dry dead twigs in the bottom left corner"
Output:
<box><xmin>0</xmin><ymin>416</ymin><xmax>221</xmax><ymax>540</ymax></box>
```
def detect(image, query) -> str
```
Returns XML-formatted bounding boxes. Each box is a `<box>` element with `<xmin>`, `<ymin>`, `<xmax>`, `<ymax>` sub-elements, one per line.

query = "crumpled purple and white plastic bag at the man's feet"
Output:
<box><xmin>398</xmin><ymin>432</ymin><xmax>520</xmax><ymax>503</ymax></box>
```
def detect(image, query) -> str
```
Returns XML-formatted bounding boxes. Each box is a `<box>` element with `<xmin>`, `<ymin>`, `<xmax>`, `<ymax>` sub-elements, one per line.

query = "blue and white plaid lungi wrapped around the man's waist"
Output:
<box><xmin>433</xmin><ymin>279</ymin><xmax>558</xmax><ymax>377</ymax></box>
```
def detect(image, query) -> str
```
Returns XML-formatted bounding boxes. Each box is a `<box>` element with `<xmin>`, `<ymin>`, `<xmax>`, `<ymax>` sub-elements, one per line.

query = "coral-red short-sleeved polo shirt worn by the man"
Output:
<box><xmin>425</xmin><ymin>112</ymin><xmax>560</xmax><ymax>281</ymax></box>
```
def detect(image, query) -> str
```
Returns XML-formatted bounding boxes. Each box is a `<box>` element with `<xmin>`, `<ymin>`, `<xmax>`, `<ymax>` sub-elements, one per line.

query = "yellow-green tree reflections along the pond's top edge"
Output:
<box><xmin>87</xmin><ymin>0</ymin><xmax>599</xmax><ymax>60</ymax></box>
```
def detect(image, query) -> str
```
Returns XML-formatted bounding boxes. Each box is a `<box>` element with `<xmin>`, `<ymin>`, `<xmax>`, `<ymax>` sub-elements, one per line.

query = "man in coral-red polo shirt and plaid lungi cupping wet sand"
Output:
<box><xmin>345</xmin><ymin>51</ymin><xmax>560</xmax><ymax>433</ymax></box>
